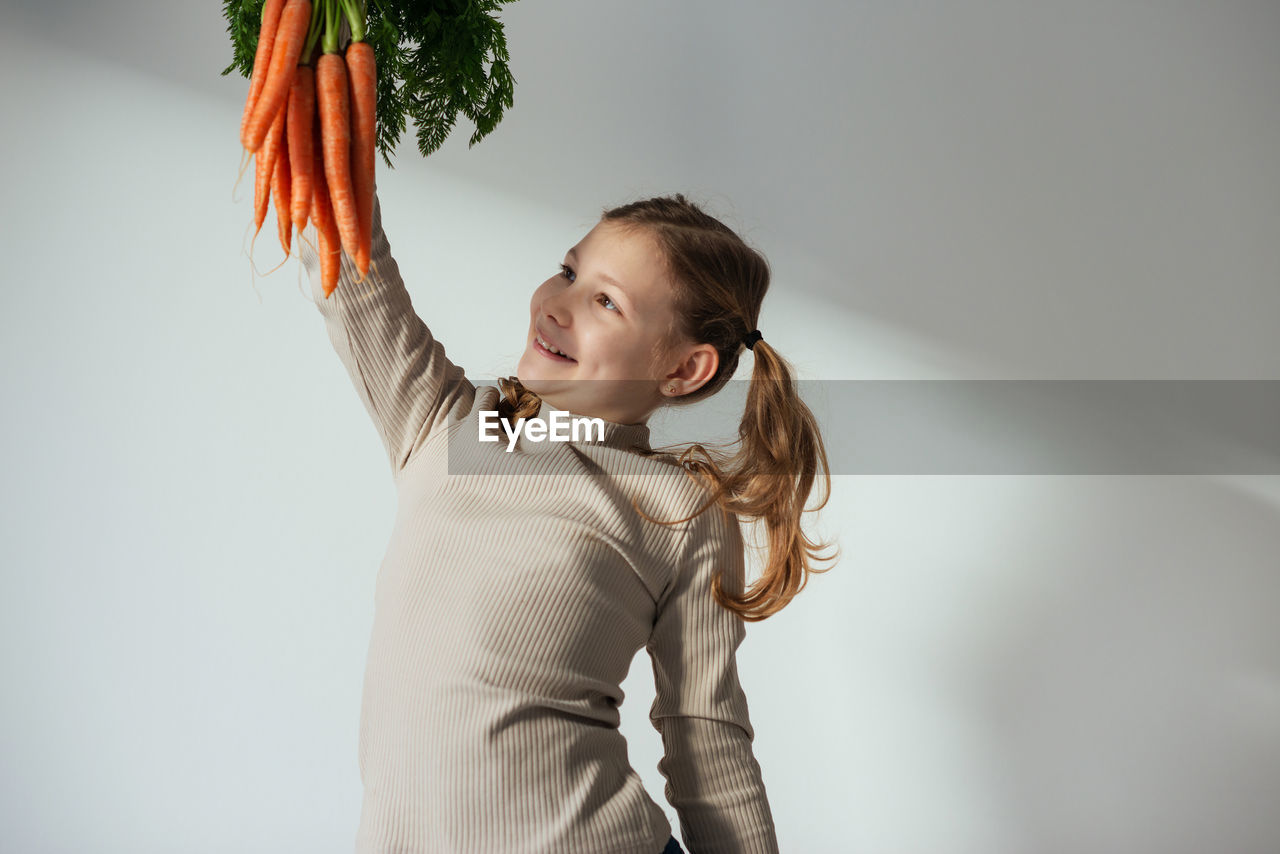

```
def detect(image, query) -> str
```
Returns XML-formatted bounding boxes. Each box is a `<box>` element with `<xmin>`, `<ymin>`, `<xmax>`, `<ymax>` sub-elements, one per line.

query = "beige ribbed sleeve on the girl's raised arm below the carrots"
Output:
<box><xmin>300</xmin><ymin>195</ymin><xmax>475</xmax><ymax>481</ymax></box>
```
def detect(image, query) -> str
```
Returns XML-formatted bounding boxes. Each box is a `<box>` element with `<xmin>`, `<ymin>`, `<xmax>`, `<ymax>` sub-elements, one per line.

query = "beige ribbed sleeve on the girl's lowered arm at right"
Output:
<box><xmin>646</xmin><ymin>507</ymin><xmax>778</xmax><ymax>854</ymax></box>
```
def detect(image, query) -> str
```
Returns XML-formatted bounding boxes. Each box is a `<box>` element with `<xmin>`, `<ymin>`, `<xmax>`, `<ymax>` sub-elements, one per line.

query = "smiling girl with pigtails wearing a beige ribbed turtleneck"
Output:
<box><xmin>301</xmin><ymin>186</ymin><xmax>829</xmax><ymax>854</ymax></box>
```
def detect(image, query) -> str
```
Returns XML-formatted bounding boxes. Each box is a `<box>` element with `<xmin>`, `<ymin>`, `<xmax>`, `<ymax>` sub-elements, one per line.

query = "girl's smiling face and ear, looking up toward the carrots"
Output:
<box><xmin>516</xmin><ymin>220</ymin><xmax>716</xmax><ymax>424</ymax></box>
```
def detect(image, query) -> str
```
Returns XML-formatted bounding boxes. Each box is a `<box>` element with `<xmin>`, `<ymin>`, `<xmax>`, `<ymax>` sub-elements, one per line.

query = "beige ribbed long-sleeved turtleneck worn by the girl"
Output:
<box><xmin>302</xmin><ymin>195</ymin><xmax>777</xmax><ymax>854</ymax></box>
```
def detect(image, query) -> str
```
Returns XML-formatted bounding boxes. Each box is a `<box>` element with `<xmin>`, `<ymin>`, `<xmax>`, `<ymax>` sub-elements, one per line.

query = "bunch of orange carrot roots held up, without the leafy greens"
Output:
<box><xmin>241</xmin><ymin>0</ymin><xmax>378</xmax><ymax>298</ymax></box>
